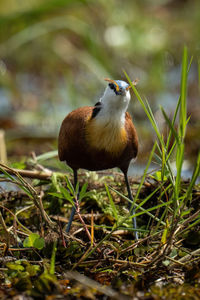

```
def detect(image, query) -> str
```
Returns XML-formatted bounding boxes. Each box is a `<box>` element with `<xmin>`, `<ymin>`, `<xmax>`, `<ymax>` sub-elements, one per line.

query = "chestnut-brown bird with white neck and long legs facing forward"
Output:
<box><xmin>58</xmin><ymin>78</ymin><xmax>138</xmax><ymax>240</ymax></box>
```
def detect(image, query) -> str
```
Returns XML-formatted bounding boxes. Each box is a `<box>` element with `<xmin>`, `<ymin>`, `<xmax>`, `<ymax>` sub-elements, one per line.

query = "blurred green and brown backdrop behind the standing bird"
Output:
<box><xmin>0</xmin><ymin>0</ymin><xmax>200</xmax><ymax>176</ymax></box>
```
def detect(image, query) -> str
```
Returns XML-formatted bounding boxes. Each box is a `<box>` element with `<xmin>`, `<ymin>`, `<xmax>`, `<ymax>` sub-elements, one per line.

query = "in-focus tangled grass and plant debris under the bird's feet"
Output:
<box><xmin>0</xmin><ymin>47</ymin><xmax>200</xmax><ymax>299</ymax></box>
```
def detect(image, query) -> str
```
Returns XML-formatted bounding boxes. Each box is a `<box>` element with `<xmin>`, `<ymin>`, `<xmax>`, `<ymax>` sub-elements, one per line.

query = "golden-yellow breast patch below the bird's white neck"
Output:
<box><xmin>86</xmin><ymin>119</ymin><xmax>127</xmax><ymax>156</ymax></box>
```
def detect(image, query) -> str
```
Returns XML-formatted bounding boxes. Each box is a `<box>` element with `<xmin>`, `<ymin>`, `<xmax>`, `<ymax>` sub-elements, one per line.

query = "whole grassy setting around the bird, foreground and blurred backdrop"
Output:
<box><xmin>0</xmin><ymin>0</ymin><xmax>200</xmax><ymax>300</ymax></box>
